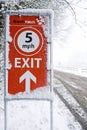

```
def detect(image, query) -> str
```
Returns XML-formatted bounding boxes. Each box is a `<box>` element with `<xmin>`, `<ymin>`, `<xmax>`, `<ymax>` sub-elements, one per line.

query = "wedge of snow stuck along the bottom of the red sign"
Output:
<box><xmin>6</xmin><ymin>86</ymin><xmax>52</xmax><ymax>100</ymax></box>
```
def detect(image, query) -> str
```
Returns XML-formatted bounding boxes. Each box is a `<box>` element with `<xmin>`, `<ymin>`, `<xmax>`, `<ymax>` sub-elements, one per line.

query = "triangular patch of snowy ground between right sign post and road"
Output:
<box><xmin>54</xmin><ymin>95</ymin><xmax>82</xmax><ymax>130</ymax></box>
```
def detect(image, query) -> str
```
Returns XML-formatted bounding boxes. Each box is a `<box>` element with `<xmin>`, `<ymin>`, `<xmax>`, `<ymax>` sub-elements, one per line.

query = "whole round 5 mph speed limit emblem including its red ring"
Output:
<box><xmin>14</xmin><ymin>27</ymin><xmax>43</xmax><ymax>56</ymax></box>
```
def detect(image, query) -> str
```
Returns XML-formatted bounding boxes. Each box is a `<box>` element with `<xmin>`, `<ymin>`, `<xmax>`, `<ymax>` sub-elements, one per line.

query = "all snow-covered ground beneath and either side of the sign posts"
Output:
<box><xmin>0</xmin><ymin>77</ymin><xmax>82</xmax><ymax>130</ymax></box>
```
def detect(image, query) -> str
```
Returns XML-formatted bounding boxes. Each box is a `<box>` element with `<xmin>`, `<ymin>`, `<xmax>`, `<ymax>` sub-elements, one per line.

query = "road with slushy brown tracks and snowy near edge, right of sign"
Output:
<box><xmin>54</xmin><ymin>71</ymin><xmax>87</xmax><ymax>130</ymax></box>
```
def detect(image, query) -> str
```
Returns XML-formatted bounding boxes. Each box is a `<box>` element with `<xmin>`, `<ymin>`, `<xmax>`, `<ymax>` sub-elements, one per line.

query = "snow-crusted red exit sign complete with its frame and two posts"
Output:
<box><xmin>4</xmin><ymin>9</ymin><xmax>53</xmax><ymax>130</ymax></box>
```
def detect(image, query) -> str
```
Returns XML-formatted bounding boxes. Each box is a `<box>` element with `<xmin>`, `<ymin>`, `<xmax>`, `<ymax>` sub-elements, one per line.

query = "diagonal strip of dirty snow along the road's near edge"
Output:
<box><xmin>54</xmin><ymin>74</ymin><xmax>87</xmax><ymax>130</ymax></box>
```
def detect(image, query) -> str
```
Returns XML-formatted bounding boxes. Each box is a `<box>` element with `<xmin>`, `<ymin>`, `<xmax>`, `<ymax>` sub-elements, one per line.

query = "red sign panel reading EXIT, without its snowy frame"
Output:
<box><xmin>7</xmin><ymin>15</ymin><xmax>47</xmax><ymax>94</ymax></box>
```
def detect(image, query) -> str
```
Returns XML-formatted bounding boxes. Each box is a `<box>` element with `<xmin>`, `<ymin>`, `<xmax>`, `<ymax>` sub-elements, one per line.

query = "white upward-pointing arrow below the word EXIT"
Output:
<box><xmin>19</xmin><ymin>71</ymin><xmax>36</xmax><ymax>93</ymax></box>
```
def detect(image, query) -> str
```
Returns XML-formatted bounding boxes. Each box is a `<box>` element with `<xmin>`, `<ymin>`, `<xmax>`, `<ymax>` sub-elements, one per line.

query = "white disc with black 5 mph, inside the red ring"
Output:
<box><xmin>17</xmin><ymin>30</ymin><xmax>40</xmax><ymax>52</ymax></box>
